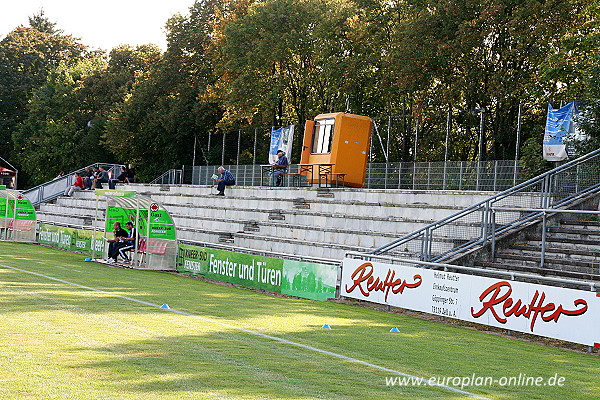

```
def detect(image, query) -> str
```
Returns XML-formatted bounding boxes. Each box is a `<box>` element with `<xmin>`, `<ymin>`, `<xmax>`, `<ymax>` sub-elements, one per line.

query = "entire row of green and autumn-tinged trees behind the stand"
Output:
<box><xmin>0</xmin><ymin>0</ymin><xmax>600</xmax><ymax>183</ymax></box>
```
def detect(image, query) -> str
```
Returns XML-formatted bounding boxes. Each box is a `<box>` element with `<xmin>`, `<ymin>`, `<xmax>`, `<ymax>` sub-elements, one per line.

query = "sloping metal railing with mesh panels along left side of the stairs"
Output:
<box><xmin>369</xmin><ymin>149</ymin><xmax>600</xmax><ymax>262</ymax></box>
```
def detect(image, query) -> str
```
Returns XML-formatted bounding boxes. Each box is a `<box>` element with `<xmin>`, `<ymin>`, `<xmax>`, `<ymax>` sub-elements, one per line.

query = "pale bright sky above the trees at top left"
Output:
<box><xmin>0</xmin><ymin>0</ymin><xmax>194</xmax><ymax>50</ymax></box>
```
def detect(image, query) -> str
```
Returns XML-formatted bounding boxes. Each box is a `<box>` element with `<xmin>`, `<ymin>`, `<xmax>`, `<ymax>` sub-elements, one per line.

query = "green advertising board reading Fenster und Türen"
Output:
<box><xmin>177</xmin><ymin>244</ymin><xmax>338</xmax><ymax>300</ymax></box>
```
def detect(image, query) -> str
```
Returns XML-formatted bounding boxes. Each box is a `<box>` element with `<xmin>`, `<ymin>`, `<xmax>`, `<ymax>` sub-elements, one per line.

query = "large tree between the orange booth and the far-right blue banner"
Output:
<box><xmin>386</xmin><ymin>0</ymin><xmax>583</xmax><ymax>159</ymax></box>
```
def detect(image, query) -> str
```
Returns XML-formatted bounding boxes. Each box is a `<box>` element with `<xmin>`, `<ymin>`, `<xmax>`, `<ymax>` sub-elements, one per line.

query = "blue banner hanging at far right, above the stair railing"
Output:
<box><xmin>543</xmin><ymin>102</ymin><xmax>575</xmax><ymax>161</ymax></box>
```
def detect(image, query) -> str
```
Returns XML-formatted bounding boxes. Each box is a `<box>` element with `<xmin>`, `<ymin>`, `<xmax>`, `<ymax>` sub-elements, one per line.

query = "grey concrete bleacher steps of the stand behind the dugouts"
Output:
<box><xmin>38</xmin><ymin>184</ymin><xmax>500</xmax><ymax>259</ymax></box>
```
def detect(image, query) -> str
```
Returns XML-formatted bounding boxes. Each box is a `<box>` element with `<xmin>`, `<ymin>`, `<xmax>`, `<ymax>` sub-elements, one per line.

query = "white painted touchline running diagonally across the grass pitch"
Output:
<box><xmin>0</xmin><ymin>264</ymin><xmax>489</xmax><ymax>400</ymax></box>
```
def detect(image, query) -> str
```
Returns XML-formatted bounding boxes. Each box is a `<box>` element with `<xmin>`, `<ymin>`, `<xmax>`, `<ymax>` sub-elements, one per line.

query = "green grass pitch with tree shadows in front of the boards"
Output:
<box><xmin>0</xmin><ymin>243</ymin><xmax>600</xmax><ymax>400</ymax></box>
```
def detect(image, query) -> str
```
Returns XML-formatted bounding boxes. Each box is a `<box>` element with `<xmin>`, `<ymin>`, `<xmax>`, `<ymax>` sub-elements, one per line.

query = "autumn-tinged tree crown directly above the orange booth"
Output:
<box><xmin>211</xmin><ymin>0</ymin><xmax>357</xmax><ymax>125</ymax></box>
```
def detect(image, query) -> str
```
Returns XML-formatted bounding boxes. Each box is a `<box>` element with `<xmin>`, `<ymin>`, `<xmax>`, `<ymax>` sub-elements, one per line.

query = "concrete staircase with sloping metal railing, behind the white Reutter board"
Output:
<box><xmin>362</xmin><ymin>149</ymin><xmax>600</xmax><ymax>285</ymax></box>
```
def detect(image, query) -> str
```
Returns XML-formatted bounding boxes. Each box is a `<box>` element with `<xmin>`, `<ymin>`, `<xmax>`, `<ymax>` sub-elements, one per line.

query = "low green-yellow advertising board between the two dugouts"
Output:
<box><xmin>38</xmin><ymin>224</ymin><xmax>104</xmax><ymax>252</ymax></box>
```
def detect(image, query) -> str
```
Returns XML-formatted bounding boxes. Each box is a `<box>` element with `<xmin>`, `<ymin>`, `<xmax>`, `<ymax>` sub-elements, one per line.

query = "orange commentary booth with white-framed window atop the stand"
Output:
<box><xmin>300</xmin><ymin>112</ymin><xmax>373</xmax><ymax>187</ymax></box>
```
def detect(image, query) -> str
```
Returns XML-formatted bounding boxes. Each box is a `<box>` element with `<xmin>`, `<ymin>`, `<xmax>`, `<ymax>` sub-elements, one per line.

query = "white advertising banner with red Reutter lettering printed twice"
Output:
<box><xmin>340</xmin><ymin>258</ymin><xmax>600</xmax><ymax>346</ymax></box>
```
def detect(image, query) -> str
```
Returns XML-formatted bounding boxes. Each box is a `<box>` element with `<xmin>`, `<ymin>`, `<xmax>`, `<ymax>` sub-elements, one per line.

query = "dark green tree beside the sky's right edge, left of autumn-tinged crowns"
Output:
<box><xmin>105</xmin><ymin>1</ymin><xmax>221</xmax><ymax>180</ymax></box>
